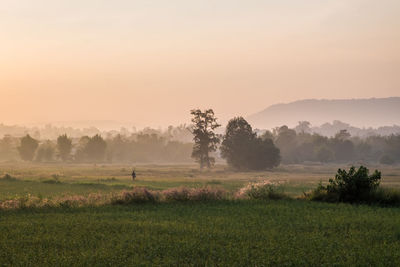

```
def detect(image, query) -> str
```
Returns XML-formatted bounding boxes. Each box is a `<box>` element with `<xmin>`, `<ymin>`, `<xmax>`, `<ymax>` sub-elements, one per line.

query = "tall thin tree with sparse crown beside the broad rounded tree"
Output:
<box><xmin>190</xmin><ymin>109</ymin><xmax>221</xmax><ymax>169</ymax></box>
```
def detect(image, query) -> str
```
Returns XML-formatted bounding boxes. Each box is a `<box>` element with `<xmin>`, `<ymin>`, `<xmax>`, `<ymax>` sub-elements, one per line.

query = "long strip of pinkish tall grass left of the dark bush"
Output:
<box><xmin>0</xmin><ymin>181</ymin><xmax>288</xmax><ymax>210</ymax></box>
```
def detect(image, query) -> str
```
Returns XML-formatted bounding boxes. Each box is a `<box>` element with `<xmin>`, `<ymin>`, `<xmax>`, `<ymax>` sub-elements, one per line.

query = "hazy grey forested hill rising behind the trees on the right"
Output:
<box><xmin>247</xmin><ymin>97</ymin><xmax>400</xmax><ymax>129</ymax></box>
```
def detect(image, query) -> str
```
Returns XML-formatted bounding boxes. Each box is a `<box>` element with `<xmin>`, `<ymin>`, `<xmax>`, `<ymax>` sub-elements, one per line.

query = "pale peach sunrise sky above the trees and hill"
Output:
<box><xmin>0</xmin><ymin>0</ymin><xmax>400</xmax><ymax>127</ymax></box>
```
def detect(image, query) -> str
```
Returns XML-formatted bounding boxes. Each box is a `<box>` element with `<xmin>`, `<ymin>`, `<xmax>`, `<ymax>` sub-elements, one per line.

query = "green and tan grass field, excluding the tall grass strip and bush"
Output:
<box><xmin>0</xmin><ymin>163</ymin><xmax>400</xmax><ymax>266</ymax></box>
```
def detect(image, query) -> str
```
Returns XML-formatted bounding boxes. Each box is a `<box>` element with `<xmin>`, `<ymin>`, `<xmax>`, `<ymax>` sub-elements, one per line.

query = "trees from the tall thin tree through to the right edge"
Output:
<box><xmin>191</xmin><ymin>110</ymin><xmax>400</xmax><ymax>170</ymax></box>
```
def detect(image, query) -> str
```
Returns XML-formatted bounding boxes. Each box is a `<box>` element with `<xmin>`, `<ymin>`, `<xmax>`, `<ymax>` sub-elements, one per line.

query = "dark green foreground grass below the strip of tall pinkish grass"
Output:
<box><xmin>0</xmin><ymin>201</ymin><xmax>400</xmax><ymax>266</ymax></box>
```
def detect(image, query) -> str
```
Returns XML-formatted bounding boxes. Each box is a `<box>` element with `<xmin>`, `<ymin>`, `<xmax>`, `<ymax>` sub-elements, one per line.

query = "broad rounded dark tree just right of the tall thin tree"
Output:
<box><xmin>221</xmin><ymin>117</ymin><xmax>280</xmax><ymax>170</ymax></box>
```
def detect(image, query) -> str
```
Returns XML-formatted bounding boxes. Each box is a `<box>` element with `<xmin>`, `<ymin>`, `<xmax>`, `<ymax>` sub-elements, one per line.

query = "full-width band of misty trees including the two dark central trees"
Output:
<box><xmin>0</xmin><ymin>109</ymin><xmax>400</xmax><ymax>170</ymax></box>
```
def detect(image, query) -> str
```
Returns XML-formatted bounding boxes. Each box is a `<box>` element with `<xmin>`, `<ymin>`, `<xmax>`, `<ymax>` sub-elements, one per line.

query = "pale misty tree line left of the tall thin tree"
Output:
<box><xmin>0</xmin><ymin>133</ymin><xmax>193</xmax><ymax>163</ymax></box>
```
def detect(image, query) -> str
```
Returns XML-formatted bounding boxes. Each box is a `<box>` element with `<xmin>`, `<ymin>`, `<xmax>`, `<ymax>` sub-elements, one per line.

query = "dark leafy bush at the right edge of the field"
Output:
<box><xmin>306</xmin><ymin>166</ymin><xmax>400</xmax><ymax>205</ymax></box>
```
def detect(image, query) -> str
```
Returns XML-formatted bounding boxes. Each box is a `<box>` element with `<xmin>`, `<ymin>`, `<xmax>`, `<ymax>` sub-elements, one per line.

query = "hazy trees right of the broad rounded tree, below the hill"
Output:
<box><xmin>262</xmin><ymin>122</ymin><xmax>400</xmax><ymax>164</ymax></box>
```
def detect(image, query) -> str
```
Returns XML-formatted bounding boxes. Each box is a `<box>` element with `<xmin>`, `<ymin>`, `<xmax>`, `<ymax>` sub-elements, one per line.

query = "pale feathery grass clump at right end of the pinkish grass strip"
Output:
<box><xmin>236</xmin><ymin>180</ymin><xmax>289</xmax><ymax>200</ymax></box>
